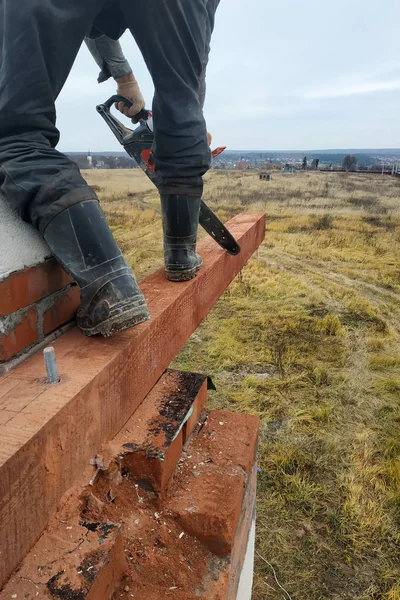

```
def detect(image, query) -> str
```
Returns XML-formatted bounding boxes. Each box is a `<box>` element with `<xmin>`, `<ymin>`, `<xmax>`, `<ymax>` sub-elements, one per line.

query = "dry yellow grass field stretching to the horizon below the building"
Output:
<box><xmin>86</xmin><ymin>171</ymin><xmax>400</xmax><ymax>600</ymax></box>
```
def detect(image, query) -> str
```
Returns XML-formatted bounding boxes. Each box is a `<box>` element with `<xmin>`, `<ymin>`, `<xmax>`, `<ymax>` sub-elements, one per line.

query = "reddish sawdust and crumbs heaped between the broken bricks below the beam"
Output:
<box><xmin>81</xmin><ymin>462</ymin><xmax>219</xmax><ymax>598</ymax></box>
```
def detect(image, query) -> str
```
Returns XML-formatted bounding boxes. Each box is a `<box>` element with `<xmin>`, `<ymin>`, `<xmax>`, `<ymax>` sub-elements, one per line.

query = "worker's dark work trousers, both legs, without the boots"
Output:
<box><xmin>0</xmin><ymin>0</ymin><xmax>219</xmax><ymax>232</ymax></box>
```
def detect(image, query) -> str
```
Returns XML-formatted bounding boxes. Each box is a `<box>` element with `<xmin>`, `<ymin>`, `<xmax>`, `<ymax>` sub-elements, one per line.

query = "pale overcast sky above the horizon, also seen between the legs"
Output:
<box><xmin>57</xmin><ymin>0</ymin><xmax>400</xmax><ymax>151</ymax></box>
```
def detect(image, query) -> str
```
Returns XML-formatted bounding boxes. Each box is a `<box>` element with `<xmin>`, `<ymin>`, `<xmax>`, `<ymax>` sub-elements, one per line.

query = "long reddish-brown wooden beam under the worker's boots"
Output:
<box><xmin>0</xmin><ymin>213</ymin><xmax>265</xmax><ymax>587</ymax></box>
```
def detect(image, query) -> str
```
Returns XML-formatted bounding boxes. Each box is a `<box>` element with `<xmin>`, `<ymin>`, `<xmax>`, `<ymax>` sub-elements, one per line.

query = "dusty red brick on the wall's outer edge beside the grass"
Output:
<box><xmin>169</xmin><ymin>411</ymin><xmax>259</xmax><ymax>554</ymax></box>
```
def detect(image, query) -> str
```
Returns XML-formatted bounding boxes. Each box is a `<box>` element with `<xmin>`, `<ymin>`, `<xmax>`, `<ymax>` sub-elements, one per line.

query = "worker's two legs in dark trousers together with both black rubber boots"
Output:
<box><xmin>0</xmin><ymin>0</ymin><xmax>219</xmax><ymax>336</ymax></box>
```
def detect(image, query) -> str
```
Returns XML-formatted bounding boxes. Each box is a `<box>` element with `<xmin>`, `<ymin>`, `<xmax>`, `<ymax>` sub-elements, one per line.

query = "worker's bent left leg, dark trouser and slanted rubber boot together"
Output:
<box><xmin>0</xmin><ymin>0</ymin><xmax>148</xmax><ymax>335</ymax></box>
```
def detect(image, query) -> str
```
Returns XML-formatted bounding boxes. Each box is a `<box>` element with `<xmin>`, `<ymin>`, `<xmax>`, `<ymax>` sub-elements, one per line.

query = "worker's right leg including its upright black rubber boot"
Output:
<box><xmin>119</xmin><ymin>0</ymin><xmax>218</xmax><ymax>281</ymax></box>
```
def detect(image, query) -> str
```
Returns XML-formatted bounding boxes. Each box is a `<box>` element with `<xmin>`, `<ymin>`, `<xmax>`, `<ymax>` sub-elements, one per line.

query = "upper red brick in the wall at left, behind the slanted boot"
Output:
<box><xmin>0</xmin><ymin>258</ymin><xmax>72</xmax><ymax>316</ymax></box>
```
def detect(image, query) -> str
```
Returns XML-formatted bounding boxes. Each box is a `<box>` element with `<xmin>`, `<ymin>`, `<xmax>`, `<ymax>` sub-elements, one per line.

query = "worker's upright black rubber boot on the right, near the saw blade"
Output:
<box><xmin>161</xmin><ymin>195</ymin><xmax>203</xmax><ymax>281</ymax></box>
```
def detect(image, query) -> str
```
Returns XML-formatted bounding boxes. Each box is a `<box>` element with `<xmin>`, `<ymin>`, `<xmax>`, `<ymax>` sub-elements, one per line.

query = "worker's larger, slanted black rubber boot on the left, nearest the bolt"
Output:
<box><xmin>44</xmin><ymin>199</ymin><xmax>150</xmax><ymax>337</ymax></box>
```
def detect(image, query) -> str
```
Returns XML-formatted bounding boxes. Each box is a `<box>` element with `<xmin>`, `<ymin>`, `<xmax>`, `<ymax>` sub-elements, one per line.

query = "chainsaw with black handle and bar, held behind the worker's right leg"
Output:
<box><xmin>96</xmin><ymin>95</ymin><xmax>240</xmax><ymax>255</ymax></box>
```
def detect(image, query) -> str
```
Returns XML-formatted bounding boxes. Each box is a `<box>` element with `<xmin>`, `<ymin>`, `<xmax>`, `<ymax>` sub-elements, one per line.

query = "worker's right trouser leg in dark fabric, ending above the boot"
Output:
<box><xmin>119</xmin><ymin>0</ymin><xmax>218</xmax><ymax>194</ymax></box>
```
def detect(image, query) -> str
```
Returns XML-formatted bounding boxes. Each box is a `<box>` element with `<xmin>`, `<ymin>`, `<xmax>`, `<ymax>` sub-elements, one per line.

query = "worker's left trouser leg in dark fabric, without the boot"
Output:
<box><xmin>0</xmin><ymin>0</ymin><xmax>101</xmax><ymax>231</ymax></box>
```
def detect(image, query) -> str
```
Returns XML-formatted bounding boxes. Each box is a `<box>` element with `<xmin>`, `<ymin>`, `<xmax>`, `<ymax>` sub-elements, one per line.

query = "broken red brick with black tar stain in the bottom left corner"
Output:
<box><xmin>0</xmin><ymin>515</ymin><xmax>127</xmax><ymax>600</ymax></box>
